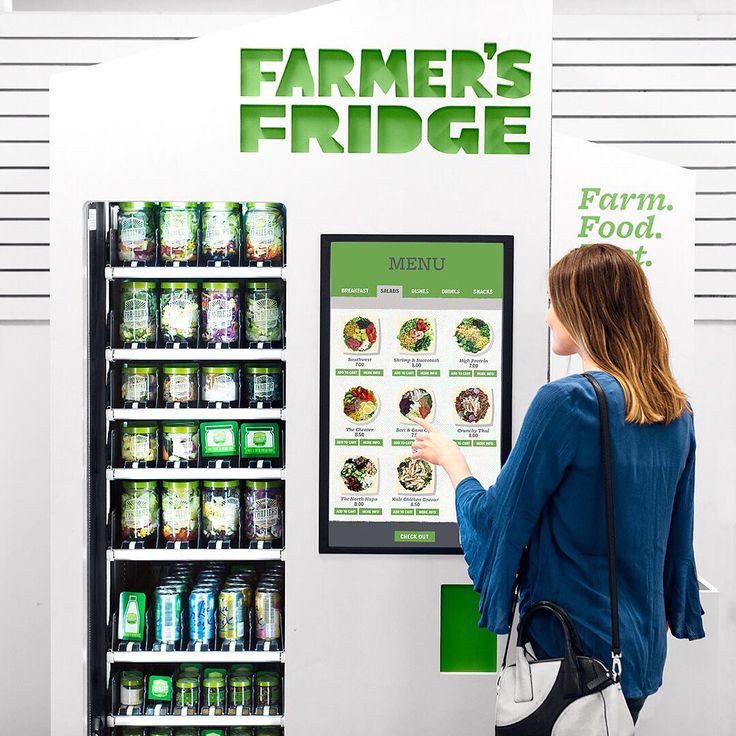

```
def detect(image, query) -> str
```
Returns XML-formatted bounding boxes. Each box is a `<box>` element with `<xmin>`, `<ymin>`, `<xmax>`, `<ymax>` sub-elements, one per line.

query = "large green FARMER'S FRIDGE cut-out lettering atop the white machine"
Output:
<box><xmin>240</xmin><ymin>43</ymin><xmax>532</xmax><ymax>155</ymax></box>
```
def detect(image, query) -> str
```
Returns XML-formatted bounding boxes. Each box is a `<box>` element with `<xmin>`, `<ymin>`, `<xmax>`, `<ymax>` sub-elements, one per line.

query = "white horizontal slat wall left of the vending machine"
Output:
<box><xmin>0</xmin><ymin>8</ymin><xmax>262</xmax><ymax>320</ymax></box>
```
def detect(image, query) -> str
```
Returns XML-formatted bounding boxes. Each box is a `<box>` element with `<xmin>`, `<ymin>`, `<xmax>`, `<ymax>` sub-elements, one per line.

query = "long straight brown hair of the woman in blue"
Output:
<box><xmin>549</xmin><ymin>243</ymin><xmax>689</xmax><ymax>424</ymax></box>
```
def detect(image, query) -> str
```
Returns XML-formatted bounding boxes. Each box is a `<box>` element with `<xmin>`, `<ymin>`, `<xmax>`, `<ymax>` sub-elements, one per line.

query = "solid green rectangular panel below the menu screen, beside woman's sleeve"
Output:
<box><xmin>440</xmin><ymin>585</ymin><xmax>497</xmax><ymax>672</ymax></box>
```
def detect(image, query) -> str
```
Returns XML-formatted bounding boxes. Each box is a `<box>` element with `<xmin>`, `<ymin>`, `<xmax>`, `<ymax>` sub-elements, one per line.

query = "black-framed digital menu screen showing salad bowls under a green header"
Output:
<box><xmin>320</xmin><ymin>235</ymin><xmax>513</xmax><ymax>554</ymax></box>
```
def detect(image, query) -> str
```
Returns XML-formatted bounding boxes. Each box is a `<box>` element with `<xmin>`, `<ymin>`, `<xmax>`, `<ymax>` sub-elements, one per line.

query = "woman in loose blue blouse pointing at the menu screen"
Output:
<box><xmin>413</xmin><ymin>244</ymin><xmax>704</xmax><ymax>722</ymax></box>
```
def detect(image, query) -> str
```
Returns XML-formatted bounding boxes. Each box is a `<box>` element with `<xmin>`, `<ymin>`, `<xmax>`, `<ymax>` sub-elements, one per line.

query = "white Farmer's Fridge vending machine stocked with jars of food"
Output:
<box><xmin>51</xmin><ymin>0</ymin><xmax>551</xmax><ymax>736</ymax></box>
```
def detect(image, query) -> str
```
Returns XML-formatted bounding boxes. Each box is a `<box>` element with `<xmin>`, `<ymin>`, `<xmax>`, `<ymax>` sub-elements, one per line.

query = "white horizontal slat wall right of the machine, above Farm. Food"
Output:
<box><xmin>552</xmin><ymin>15</ymin><xmax>736</xmax><ymax>320</ymax></box>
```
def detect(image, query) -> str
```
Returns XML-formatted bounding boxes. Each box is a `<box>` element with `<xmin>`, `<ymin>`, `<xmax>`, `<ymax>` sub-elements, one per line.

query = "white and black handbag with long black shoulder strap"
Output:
<box><xmin>496</xmin><ymin>373</ymin><xmax>634</xmax><ymax>736</ymax></box>
